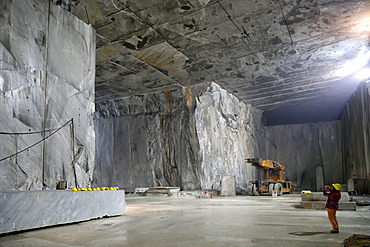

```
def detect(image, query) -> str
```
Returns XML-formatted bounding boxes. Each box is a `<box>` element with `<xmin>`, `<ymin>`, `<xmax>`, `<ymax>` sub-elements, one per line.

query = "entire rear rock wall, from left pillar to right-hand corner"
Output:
<box><xmin>94</xmin><ymin>80</ymin><xmax>346</xmax><ymax>193</ymax></box>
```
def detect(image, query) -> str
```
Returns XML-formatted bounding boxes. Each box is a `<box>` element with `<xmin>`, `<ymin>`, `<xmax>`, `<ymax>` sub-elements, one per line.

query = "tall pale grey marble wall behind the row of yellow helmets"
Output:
<box><xmin>0</xmin><ymin>0</ymin><xmax>96</xmax><ymax>190</ymax></box>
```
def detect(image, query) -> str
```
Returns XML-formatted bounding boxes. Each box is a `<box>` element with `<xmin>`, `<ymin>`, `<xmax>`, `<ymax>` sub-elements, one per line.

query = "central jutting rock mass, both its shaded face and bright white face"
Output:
<box><xmin>94</xmin><ymin>84</ymin><xmax>264</xmax><ymax>190</ymax></box>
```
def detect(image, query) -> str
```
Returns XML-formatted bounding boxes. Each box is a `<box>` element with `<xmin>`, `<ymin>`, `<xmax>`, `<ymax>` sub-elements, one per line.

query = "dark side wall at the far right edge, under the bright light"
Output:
<box><xmin>341</xmin><ymin>82</ymin><xmax>370</xmax><ymax>193</ymax></box>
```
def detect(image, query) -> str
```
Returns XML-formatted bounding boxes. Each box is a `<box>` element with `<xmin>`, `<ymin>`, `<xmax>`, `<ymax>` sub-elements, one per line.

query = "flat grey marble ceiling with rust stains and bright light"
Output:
<box><xmin>54</xmin><ymin>0</ymin><xmax>370</xmax><ymax>125</ymax></box>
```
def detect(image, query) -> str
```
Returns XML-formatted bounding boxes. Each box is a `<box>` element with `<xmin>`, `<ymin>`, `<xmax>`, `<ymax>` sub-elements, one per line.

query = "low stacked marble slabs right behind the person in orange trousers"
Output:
<box><xmin>301</xmin><ymin>192</ymin><xmax>356</xmax><ymax>210</ymax></box>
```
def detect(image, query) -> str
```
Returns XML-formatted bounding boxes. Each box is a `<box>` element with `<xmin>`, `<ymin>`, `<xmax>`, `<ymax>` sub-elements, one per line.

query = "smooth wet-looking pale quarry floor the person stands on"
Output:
<box><xmin>0</xmin><ymin>194</ymin><xmax>370</xmax><ymax>247</ymax></box>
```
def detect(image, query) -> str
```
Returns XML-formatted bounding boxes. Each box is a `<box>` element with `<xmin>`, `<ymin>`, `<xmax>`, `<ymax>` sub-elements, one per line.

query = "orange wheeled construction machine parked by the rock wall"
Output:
<box><xmin>246</xmin><ymin>158</ymin><xmax>294</xmax><ymax>196</ymax></box>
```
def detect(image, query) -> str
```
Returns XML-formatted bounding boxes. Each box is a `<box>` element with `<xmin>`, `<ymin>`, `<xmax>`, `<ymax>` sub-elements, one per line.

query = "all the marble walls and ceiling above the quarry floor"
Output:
<box><xmin>0</xmin><ymin>0</ymin><xmax>370</xmax><ymax>231</ymax></box>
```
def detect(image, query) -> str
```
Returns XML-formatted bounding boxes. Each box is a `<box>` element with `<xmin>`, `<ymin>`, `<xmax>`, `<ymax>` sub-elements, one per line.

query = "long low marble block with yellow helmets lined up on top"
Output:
<box><xmin>0</xmin><ymin>190</ymin><xmax>126</xmax><ymax>234</ymax></box>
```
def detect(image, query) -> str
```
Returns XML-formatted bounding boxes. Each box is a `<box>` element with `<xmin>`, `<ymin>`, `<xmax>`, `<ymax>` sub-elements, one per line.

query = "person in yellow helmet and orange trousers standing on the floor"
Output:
<box><xmin>323</xmin><ymin>184</ymin><xmax>342</xmax><ymax>233</ymax></box>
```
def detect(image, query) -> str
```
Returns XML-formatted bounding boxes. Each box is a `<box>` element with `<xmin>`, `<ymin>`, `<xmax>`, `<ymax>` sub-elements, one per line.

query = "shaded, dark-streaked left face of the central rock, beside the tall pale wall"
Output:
<box><xmin>94</xmin><ymin>87</ymin><xmax>202</xmax><ymax>189</ymax></box>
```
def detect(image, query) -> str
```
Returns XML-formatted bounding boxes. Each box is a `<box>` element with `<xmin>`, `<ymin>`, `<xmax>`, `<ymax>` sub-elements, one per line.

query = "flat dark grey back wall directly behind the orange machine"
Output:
<box><xmin>266</xmin><ymin>121</ymin><xmax>344</xmax><ymax>191</ymax></box>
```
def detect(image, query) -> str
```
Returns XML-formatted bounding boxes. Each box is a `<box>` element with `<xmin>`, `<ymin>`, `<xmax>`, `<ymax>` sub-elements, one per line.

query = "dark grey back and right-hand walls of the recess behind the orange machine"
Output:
<box><xmin>266</xmin><ymin>82</ymin><xmax>370</xmax><ymax>194</ymax></box>
